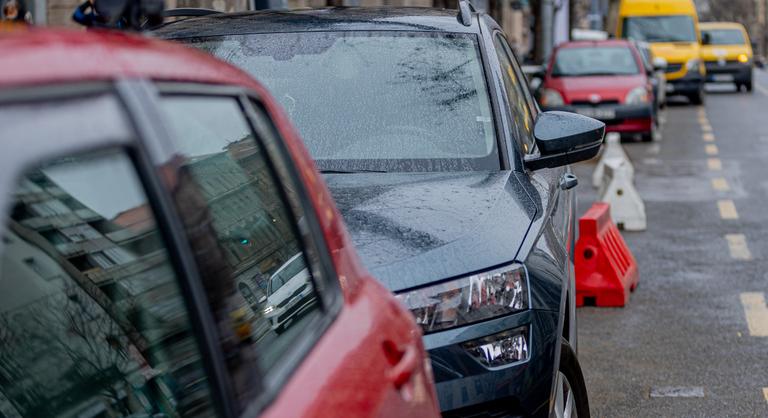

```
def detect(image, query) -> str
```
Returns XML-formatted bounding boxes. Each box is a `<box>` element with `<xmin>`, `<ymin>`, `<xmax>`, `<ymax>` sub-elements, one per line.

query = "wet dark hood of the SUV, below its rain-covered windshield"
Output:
<box><xmin>325</xmin><ymin>171</ymin><xmax>537</xmax><ymax>291</ymax></box>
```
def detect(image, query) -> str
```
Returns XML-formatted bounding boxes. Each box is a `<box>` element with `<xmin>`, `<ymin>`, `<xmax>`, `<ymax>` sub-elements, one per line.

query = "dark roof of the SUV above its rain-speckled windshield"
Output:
<box><xmin>154</xmin><ymin>7</ymin><xmax>480</xmax><ymax>38</ymax></box>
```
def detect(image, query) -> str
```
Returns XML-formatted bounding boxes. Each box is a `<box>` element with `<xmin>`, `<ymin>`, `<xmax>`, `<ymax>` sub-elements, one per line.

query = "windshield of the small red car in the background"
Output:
<box><xmin>552</xmin><ymin>46</ymin><xmax>640</xmax><ymax>77</ymax></box>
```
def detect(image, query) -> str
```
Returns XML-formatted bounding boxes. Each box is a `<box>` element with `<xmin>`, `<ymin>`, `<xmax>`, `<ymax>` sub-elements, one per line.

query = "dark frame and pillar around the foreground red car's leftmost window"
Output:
<box><xmin>0</xmin><ymin>80</ymin><xmax>234</xmax><ymax>417</ymax></box>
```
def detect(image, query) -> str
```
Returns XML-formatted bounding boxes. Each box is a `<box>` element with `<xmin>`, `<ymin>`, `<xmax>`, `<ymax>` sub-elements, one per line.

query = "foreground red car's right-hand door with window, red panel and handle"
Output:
<box><xmin>145</xmin><ymin>84</ymin><xmax>439</xmax><ymax>418</ymax></box>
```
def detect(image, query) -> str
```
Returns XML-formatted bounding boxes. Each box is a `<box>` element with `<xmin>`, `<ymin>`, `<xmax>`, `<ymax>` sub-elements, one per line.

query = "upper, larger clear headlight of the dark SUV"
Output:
<box><xmin>396</xmin><ymin>263</ymin><xmax>529</xmax><ymax>334</ymax></box>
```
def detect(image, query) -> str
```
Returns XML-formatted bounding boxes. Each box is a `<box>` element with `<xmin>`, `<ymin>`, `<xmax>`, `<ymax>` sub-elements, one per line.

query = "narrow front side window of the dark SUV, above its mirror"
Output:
<box><xmin>493</xmin><ymin>34</ymin><xmax>535</xmax><ymax>154</ymax></box>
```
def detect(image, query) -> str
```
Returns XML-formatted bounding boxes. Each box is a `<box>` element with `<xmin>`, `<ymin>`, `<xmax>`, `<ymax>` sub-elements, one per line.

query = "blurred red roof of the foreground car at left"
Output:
<box><xmin>0</xmin><ymin>29</ymin><xmax>263</xmax><ymax>92</ymax></box>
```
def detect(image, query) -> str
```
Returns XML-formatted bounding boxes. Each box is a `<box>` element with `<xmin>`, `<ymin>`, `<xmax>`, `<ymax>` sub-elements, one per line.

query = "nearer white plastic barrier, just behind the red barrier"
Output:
<box><xmin>597</xmin><ymin>158</ymin><xmax>647</xmax><ymax>231</ymax></box>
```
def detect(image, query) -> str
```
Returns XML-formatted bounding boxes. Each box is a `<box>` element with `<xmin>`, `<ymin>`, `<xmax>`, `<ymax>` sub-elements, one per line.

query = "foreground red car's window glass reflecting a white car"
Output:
<box><xmin>162</xmin><ymin>96</ymin><xmax>320</xmax><ymax>408</ymax></box>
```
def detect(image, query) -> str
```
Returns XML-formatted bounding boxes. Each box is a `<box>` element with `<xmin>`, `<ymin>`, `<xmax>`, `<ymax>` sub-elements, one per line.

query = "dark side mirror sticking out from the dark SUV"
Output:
<box><xmin>525</xmin><ymin>111</ymin><xmax>605</xmax><ymax>170</ymax></box>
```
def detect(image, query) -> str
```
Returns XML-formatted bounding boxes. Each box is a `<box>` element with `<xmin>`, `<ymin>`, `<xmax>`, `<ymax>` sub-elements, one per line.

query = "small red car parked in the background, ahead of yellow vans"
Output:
<box><xmin>538</xmin><ymin>40</ymin><xmax>658</xmax><ymax>141</ymax></box>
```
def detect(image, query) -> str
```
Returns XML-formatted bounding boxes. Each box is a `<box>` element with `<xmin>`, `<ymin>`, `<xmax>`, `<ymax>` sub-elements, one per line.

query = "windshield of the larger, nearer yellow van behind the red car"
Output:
<box><xmin>622</xmin><ymin>15</ymin><xmax>698</xmax><ymax>42</ymax></box>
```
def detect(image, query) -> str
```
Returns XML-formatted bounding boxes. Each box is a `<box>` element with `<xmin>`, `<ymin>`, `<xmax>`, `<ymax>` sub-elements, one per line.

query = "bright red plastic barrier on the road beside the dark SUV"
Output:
<box><xmin>575</xmin><ymin>202</ymin><xmax>639</xmax><ymax>307</ymax></box>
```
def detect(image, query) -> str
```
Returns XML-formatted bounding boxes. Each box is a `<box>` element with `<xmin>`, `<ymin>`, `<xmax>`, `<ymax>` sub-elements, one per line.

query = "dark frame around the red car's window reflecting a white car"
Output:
<box><xmin>152</xmin><ymin>82</ymin><xmax>344</xmax><ymax>416</ymax></box>
